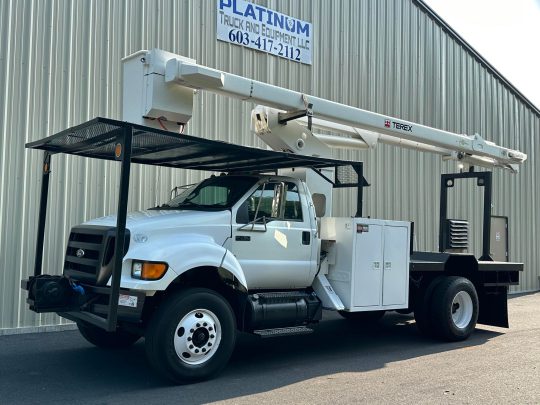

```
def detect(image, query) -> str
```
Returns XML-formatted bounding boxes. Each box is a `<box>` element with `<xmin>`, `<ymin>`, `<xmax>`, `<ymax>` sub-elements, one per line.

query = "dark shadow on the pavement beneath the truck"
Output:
<box><xmin>0</xmin><ymin>313</ymin><xmax>501</xmax><ymax>404</ymax></box>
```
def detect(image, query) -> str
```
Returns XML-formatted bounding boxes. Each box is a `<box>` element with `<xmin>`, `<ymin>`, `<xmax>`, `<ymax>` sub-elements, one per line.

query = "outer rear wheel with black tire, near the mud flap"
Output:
<box><xmin>431</xmin><ymin>276</ymin><xmax>478</xmax><ymax>342</ymax></box>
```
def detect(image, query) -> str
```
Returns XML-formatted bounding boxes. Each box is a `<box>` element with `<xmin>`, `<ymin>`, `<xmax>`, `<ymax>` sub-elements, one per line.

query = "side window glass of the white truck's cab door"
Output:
<box><xmin>247</xmin><ymin>182</ymin><xmax>302</xmax><ymax>222</ymax></box>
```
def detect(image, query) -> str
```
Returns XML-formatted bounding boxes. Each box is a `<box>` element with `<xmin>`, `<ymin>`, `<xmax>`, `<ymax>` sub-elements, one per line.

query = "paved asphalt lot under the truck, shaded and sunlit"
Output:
<box><xmin>0</xmin><ymin>293</ymin><xmax>540</xmax><ymax>404</ymax></box>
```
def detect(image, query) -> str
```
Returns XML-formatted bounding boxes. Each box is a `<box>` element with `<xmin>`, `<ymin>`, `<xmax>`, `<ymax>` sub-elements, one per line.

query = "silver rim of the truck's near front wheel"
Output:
<box><xmin>174</xmin><ymin>309</ymin><xmax>222</xmax><ymax>365</ymax></box>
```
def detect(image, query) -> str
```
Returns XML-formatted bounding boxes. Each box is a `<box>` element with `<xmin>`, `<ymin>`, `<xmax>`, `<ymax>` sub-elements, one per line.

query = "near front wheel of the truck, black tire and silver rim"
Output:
<box><xmin>146</xmin><ymin>288</ymin><xmax>236</xmax><ymax>383</ymax></box>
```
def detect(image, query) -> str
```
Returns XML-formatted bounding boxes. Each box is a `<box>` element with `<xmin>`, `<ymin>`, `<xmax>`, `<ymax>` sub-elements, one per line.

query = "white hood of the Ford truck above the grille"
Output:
<box><xmin>83</xmin><ymin>210</ymin><xmax>231</xmax><ymax>245</ymax></box>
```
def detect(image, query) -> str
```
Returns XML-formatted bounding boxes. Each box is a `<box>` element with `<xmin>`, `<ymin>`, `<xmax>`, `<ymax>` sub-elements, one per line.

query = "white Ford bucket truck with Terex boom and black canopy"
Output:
<box><xmin>23</xmin><ymin>50</ymin><xmax>526</xmax><ymax>382</ymax></box>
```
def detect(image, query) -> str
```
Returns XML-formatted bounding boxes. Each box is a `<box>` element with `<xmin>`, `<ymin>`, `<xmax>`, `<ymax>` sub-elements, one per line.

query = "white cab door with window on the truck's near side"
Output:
<box><xmin>231</xmin><ymin>180</ymin><xmax>316</xmax><ymax>289</ymax></box>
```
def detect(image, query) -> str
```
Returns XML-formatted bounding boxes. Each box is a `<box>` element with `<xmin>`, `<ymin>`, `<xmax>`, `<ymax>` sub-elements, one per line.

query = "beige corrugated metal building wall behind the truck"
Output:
<box><xmin>0</xmin><ymin>0</ymin><xmax>540</xmax><ymax>328</ymax></box>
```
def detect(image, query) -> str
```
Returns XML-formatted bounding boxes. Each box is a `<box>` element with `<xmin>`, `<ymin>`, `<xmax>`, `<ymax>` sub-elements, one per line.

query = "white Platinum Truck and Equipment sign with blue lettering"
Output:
<box><xmin>217</xmin><ymin>0</ymin><xmax>313</xmax><ymax>65</ymax></box>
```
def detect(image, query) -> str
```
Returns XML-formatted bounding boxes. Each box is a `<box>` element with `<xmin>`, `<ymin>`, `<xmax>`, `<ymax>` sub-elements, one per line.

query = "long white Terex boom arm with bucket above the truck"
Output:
<box><xmin>124</xmin><ymin>50</ymin><xmax>527</xmax><ymax>171</ymax></box>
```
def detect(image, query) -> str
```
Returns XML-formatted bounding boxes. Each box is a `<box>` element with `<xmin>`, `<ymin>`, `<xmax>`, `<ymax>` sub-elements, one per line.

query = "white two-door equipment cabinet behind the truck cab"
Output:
<box><xmin>321</xmin><ymin>218</ymin><xmax>410</xmax><ymax>312</ymax></box>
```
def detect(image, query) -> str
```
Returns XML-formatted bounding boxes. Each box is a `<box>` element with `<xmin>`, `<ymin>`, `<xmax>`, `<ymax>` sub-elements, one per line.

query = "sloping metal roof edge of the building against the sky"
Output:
<box><xmin>412</xmin><ymin>0</ymin><xmax>540</xmax><ymax>118</ymax></box>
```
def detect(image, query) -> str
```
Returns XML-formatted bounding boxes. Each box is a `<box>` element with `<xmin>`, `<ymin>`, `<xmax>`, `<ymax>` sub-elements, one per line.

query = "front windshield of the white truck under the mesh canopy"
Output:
<box><xmin>159</xmin><ymin>176</ymin><xmax>257</xmax><ymax>209</ymax></box>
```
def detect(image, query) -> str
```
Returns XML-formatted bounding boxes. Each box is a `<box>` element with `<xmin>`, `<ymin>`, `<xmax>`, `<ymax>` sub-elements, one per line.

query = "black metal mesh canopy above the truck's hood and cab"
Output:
<box><xmin>26</xmin><ymin>117</ymin><xmax>361</xmax><ymax>175</ymax></box>
